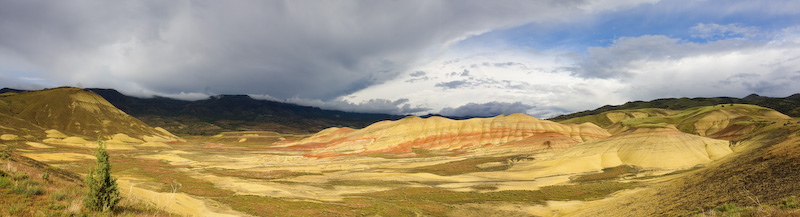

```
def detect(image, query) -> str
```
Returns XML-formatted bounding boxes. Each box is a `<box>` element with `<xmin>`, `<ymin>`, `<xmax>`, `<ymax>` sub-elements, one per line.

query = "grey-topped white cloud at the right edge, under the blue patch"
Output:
<box><xmin>575</xmin><ymin>26</ymin><xmax>800</xmax><ymax>100</ymax></box>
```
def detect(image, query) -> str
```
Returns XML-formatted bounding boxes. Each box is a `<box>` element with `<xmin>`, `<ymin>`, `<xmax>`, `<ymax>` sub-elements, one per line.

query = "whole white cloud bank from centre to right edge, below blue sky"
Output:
<box><xmin>345</xmin><ymin>25</ymin><xmax>800</xmax><ymax>118</ymax></box>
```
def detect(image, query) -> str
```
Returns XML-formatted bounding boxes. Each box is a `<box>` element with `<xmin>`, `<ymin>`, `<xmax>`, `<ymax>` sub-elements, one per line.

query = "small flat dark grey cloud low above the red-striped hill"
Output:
<box><xmin>439</xmin><ymin>102</ymin><xmax>535</xmax><ymax>117</ymax></box>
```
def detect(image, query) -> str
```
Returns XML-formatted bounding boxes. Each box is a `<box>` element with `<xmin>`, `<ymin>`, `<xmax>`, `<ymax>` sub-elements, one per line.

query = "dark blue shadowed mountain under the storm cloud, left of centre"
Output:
<box><xmin>89</xmin><ymin>89</ymin><xmax>403</xmax><ymax>135</ymax></box>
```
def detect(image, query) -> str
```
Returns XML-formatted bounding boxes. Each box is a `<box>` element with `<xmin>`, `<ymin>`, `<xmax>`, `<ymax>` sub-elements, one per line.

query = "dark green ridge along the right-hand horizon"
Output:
<box><xmin>550</xmin><ymin>93</ymin><xmax>800</xmax><ymax>121</ymax></box>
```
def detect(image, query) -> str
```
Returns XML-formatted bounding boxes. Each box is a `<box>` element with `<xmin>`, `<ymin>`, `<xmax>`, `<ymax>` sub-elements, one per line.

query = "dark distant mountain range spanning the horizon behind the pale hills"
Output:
<box><xmin>0</xmin><ymin>88</ymin><xmax>800</xmax><ymax>135</ymax></box>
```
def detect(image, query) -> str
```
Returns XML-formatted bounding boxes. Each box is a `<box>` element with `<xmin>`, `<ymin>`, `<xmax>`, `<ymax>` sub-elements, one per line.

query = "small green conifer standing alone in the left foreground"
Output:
<box><xmin>83</xmin><ymin>140</ymin><xmax>119</xmax><ymax>212</ymax></box>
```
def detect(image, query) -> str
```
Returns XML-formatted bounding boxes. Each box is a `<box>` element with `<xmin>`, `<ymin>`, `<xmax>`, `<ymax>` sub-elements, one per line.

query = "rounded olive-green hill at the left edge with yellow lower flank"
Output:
<box><xmin>0</xmin><ymin>87</ymin><xmax>177</xmax><ymax>143</ymax></box>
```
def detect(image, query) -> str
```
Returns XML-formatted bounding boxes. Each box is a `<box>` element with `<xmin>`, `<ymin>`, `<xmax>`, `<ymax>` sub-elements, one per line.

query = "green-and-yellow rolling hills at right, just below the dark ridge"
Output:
<box><xmin>561</xmin><ymin>104</ymin><xmax>791</xmax><ymax>139</ymax></box>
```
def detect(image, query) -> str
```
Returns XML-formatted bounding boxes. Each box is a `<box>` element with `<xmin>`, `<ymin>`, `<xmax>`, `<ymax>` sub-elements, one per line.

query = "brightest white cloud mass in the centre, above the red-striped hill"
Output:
<box><xmin>344</xmin><ymin>48</ymin><xmax>625</xmax><ymax>118</ymax></box>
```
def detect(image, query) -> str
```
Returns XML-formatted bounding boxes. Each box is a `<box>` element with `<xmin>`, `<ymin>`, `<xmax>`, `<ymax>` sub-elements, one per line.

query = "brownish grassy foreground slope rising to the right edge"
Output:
<box><xmin>572</xmin><ymin>120</ymin><xmax>800</xmax><ymax>216</ymax></box>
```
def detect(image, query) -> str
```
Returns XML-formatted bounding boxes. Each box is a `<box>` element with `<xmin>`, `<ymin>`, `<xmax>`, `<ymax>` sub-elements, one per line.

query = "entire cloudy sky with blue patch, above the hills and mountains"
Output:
<box><xmin>0</xmin><ymin>0</ymin><xmax>800</xmax><ymax>118</ymax></box>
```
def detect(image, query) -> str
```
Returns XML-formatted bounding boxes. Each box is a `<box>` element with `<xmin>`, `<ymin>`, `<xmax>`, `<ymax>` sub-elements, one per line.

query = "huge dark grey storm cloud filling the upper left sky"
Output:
<box><xmin>0</xmin><ymin>0</ymin><xmax>627</xmax><ymax>100</ymax></box>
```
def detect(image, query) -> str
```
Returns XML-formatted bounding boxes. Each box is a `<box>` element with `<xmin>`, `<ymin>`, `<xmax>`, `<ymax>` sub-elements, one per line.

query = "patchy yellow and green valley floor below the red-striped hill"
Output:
<box><xmin>0</xmin><ymin>132</ymin><xmax>744</xmax><ymax>216</ymax></box>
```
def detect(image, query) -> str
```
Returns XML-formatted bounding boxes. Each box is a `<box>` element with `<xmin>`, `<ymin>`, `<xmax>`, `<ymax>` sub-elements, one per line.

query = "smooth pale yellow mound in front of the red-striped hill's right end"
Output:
<box><xmin>514</xmin><ymin>127</ymin><xmax>732</xmax><ymax>176</ymax></box>
